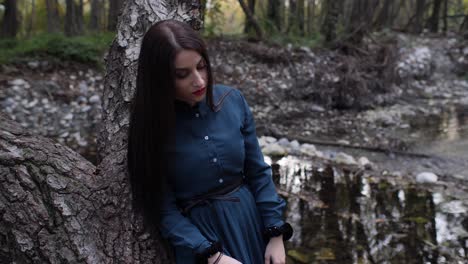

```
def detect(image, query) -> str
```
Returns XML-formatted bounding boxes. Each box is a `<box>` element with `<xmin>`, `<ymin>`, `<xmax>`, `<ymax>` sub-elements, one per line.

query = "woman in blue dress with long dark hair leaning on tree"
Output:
<box><xmin>128</xmin><ymin>20</ymin><xmax>292</xmax><ymax>264</ymax></box>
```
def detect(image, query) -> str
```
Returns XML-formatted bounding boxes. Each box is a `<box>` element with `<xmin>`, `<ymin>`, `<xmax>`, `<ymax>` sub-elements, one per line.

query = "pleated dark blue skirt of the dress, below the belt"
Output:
<box><xmin>174</xmin><ymin>185</ymin><xmax>266</xmax><ymax>264</ymax></box>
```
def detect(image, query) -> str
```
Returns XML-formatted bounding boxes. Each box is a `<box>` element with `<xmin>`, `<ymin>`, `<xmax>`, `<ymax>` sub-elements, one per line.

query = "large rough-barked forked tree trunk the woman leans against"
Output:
<box><xmin>0</xmin><ymin>0</ymin><xmax>201</xmax><ymax>263</ymax></box>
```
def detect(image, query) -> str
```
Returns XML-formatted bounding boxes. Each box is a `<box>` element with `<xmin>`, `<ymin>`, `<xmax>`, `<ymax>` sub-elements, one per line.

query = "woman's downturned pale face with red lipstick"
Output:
<box><xmin>175</xmin><ymin>50</ymin><xmax>208</xmax><ymax>106</ymax></box>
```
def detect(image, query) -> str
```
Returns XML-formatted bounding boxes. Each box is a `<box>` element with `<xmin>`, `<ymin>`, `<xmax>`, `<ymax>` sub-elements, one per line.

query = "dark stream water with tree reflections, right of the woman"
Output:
<box><xmin>273</xmin><ymin>157</ymin><xmax>468</xmax><ymax>263</ymax></box>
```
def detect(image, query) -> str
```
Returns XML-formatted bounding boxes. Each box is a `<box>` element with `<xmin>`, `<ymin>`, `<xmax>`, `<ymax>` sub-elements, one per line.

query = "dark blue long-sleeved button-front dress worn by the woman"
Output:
<box><xmin>161</xmin><ymin>85</ymin><xmax>286</xmax><ymax>264</ymax></box>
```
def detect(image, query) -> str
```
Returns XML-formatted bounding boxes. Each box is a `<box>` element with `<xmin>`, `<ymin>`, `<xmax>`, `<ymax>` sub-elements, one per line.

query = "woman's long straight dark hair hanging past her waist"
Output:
<box><xmin>127</xmin><ymin>20</ymin><xmax>213</xmax><ymax>228</ymax></box>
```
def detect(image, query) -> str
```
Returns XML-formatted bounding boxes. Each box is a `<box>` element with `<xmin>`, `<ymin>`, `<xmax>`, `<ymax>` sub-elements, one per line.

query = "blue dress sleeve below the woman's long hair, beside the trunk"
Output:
<box><xmin>160</xmin><ymin>184</ymin><xmax>211</xmax><ymax>253</ymax></box>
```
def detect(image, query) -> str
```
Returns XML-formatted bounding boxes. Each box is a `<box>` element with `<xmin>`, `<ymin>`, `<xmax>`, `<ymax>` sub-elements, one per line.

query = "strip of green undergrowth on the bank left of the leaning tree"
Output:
<box><xmin>0</xmin><ymin>32</ymin><xmax>115</xmax><ymax>66</ymax></box>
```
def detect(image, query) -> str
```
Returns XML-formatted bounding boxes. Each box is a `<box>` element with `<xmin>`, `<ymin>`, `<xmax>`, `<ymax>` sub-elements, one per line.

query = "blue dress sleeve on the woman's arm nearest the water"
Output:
<box><xmin>239</xmin><ymin>89</ymin><xmax>286</xmax><ymax>228</ymax></box>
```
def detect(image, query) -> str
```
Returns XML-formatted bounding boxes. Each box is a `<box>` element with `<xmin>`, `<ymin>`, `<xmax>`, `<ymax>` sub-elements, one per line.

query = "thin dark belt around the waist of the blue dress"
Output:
<box><xmin>177</xmin><ymin>177</ymin><xmax>244</xmax><ymax>215</ymax></box>
